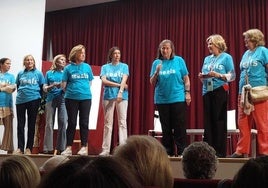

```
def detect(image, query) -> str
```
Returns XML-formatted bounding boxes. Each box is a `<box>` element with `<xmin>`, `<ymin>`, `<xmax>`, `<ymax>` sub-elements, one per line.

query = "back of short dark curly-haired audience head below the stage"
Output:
<box><xmin>182</xmin><ymin>142</ymin><xmax>218</xmax><ymax>179</ymax></box>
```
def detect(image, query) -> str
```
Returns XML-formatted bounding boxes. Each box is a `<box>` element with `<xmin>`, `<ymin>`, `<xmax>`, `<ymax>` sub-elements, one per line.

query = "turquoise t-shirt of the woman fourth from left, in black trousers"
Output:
<box><xmin>62</xmin><ymin>62</ymin><xmax>94</xmax><ymax>100</ymax></box>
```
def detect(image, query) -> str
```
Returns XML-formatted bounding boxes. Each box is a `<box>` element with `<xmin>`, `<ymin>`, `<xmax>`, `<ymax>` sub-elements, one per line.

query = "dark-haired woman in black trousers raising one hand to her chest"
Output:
<box><xmin>150</xmin><ymin>40</ymin><xmax>191</xmax><ymax>156</ymax></box>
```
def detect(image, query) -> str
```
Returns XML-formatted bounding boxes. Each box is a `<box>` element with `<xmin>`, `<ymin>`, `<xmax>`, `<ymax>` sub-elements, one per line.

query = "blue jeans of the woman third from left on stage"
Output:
<box><xmin>44</xmin><ymin>95</ymin><xmax>67</xmax><ymax>151</ymax></box>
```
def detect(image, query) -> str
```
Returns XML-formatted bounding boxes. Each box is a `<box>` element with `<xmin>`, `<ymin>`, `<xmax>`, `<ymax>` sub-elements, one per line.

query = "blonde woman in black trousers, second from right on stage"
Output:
<box><xmin>198</xmin><ymin>34</ymin><xmax>235</xmax><ymax>157</ymax></box>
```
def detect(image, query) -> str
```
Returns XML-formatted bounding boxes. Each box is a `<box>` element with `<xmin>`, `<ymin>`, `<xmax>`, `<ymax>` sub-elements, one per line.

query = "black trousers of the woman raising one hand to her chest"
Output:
<box><xmin>157</xmin><ymin>102</ymin><xmax>186</xmax><ymax>156</ymax></box>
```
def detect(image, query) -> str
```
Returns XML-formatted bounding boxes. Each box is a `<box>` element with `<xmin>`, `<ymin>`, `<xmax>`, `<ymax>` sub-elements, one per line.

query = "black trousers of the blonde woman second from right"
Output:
<box><xmin>203</xmin><ymin>87</ymin><xmax>228</xmax><ymax>157</ymax></box>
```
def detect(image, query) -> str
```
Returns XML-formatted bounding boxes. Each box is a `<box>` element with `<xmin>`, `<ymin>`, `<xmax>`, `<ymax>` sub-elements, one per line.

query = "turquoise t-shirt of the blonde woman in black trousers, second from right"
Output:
<box><xmin>202</xmin><ymin>52</ymin><xmax>235</xmax><ymax>95</ymax></box>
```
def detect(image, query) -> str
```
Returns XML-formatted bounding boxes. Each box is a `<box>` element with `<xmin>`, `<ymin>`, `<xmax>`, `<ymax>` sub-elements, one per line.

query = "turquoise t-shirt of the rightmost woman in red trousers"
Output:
<box><xmin>239</xmin><ymin>46</ymin><xmax>268</xmax><ymax>93</ymax></box>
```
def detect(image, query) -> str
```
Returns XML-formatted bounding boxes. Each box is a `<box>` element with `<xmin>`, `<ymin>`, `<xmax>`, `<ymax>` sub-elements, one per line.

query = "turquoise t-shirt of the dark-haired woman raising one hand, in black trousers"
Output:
<box><xmin>150</xmin><ymin>56</ymin><xmax>189</xmax><ymax>104</ymax></box>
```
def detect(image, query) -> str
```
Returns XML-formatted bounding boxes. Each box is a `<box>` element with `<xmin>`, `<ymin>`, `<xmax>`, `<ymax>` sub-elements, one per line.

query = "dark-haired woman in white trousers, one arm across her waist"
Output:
<box><xmin>100</xmin><ymin>47</ymin><xmax>129</xmax><ymax>156</ymax></box>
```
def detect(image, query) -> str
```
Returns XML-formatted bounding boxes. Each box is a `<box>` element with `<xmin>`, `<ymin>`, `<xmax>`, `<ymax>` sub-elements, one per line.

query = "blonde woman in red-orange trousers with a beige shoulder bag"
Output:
<box><xmin>231</xmin><ymin>29</ymin><xmax>268</xmax><ymax>158</ymax></box>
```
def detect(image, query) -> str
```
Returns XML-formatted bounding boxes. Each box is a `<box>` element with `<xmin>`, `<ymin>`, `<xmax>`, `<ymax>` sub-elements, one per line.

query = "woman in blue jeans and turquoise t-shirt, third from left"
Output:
<box><xmin>43</xmin><ymin>54</ymin><xmax>67</xmax><ymax>154</ymax></box>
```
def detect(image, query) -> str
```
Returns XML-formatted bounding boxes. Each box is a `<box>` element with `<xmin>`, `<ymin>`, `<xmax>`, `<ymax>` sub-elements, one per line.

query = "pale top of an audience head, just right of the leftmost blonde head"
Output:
<box><xmin>39</xmin><ymin>155</ymin><xmax>69</xmax><ymax>175</ymax></box>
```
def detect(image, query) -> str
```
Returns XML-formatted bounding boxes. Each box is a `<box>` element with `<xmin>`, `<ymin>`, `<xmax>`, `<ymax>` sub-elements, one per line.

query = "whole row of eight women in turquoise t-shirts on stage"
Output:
<box><xmin>0</xmin><ymin>29</ymin><xmax>268</xmax><ymax>158</ymax></box>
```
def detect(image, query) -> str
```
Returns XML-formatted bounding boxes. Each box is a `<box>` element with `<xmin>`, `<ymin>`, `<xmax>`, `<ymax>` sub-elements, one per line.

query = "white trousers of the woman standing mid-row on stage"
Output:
<box><xmin>102</xmin><ymin>100</ymin><xmax>128</xmax><ymax>153</ymax></box>
